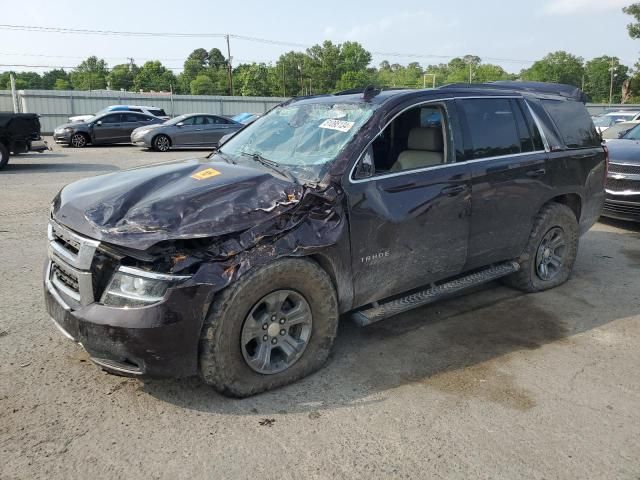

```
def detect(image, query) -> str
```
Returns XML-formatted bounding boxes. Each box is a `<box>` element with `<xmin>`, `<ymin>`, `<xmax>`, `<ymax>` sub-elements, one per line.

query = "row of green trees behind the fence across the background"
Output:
<box><xmin>0</xmin><ymin>3</ymin><xmax>640</xmax><ymax>103</ymax></box>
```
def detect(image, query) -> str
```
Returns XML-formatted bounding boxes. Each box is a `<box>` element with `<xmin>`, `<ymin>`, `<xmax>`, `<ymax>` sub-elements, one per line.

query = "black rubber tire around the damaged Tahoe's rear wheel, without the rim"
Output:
<box><xmin>503</xmin><ymin>202</ymin><xmax>580</xmax><ymax>292</ymax></box>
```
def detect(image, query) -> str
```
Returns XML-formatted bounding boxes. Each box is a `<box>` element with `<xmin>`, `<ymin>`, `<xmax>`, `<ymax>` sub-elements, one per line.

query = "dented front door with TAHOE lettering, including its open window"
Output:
<box><xmin>345</xmin><ymin>102</ymin><xmax>471</xmax><ymax>307</ymax></box>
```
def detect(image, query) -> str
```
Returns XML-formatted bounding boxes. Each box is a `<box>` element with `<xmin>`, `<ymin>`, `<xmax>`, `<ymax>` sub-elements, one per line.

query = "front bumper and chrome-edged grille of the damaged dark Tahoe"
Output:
<box><xmin>43</xmin><ymin>219</ymin><xmax>212</xmax><ymax>377</ymax></box>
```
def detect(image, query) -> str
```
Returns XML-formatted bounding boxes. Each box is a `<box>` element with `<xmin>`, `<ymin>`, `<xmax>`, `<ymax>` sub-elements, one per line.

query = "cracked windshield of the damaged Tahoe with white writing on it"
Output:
<box><xmin>219</xmin><ymin>103</ymin><xmax>376</xmax><ymax>181</ymax></box>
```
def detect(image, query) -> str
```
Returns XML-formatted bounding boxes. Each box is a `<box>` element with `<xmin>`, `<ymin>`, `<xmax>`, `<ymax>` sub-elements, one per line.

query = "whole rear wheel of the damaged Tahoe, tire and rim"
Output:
<box><xmin>504</xmin><ymin>203</ymin><xmax>580</xmax><ymax>292</ymax></box>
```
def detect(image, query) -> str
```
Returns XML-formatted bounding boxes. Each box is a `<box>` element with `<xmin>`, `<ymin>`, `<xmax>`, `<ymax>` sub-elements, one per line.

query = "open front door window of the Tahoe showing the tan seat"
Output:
<box><xmin>355</xmin><ymin>104</ymin><xmax>449</xmax><ymax>178</ymax></box>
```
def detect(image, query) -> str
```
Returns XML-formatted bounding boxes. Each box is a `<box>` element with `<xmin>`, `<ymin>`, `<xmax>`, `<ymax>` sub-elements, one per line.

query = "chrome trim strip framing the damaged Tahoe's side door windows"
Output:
<box><xmin>349</xmin><ymin>95</ymin><xmax>549</xmax><ymax>184</ymax></box>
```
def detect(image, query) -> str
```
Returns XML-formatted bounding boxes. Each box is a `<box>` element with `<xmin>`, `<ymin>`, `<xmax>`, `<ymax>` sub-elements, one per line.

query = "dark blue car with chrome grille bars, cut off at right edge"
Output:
<box><xmin>602</xmin><ymin>138</ymin><xmax>640</xmax><ymax>222</ymax></box>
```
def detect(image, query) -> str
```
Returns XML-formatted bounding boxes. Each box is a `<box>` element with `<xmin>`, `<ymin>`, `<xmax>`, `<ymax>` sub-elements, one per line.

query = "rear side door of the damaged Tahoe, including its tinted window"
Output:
<box><xmin>456</xmin><ymin>97</ymin><xmax>551</xmax><ymax>270</ymax></box>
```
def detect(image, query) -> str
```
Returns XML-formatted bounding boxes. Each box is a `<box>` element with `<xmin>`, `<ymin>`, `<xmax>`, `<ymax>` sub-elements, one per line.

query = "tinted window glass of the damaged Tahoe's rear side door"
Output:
<box><xmin>460</xmin><ymin>99</ymin><xmax>521</xmax><ymax>158</ymax></box>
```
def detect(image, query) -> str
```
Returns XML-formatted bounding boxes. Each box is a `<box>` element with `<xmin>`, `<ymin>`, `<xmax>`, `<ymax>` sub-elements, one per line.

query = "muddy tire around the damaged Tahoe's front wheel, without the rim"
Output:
<box><xmin>199</xmin><ymin>258</ymin><xmax>338</xmax><ymax>397</ymax></box>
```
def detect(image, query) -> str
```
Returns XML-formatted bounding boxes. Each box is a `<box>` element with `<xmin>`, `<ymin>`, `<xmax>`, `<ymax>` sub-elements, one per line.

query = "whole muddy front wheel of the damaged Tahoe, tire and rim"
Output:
<box><xmin>199</xmin><ymin>259</ymin><xmax>338</xmax><ymax>397</ymax></box>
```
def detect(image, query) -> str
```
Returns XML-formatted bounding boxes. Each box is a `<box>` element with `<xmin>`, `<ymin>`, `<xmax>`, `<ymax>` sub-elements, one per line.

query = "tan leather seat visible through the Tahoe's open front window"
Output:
<box><xmin>391</xmin><ymin>128</ymin><xmax>444</xmax><ymax>172</ymax></box>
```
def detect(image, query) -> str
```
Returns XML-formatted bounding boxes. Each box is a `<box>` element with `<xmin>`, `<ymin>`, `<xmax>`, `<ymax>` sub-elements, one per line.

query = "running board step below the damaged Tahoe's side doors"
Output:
<box><xmin>351</xmin><ymin>262</ymin><xmax>520</xmax><ymax>327</ymax></box>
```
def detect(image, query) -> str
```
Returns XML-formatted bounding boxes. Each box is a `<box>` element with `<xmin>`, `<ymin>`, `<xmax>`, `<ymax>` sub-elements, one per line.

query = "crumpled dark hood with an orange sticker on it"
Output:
<box><xmin>52</xmin><ymin>159</ymin><xmax>304</xmax><ymax>250</ymax></box>
